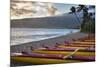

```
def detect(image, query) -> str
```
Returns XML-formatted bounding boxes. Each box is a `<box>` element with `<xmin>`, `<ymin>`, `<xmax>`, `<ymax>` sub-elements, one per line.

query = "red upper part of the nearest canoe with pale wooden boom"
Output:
<box><xmin>22</xmin><ymin>49</ymin><xmax>95</xmax><ymax>61</ymax></box>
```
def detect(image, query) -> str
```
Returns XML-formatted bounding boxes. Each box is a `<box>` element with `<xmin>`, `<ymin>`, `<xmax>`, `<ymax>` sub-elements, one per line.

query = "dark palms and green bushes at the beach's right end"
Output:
<box><xmin>70</xmin><ymin>5</ymin><xmax>95</xmax><ymax>33</ymax></box>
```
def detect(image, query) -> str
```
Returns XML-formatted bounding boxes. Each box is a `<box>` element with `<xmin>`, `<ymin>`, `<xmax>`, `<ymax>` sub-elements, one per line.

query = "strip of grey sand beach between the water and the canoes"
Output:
<box><xmin>10</xmin><ymin>32</ymin><xmax>88</xmax><ymax>53</ymax></box>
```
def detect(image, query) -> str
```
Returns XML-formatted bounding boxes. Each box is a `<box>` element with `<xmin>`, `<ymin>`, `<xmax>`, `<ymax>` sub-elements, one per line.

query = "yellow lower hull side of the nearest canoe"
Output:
<box><xmin>11</xmin><ymin>56</ymin><xmax>82</xmax><ymax>64</ymax></box>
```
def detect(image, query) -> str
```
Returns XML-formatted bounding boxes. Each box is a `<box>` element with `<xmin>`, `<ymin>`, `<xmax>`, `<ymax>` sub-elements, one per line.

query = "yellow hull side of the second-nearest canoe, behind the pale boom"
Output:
<box><xmin>32</xmin><ymin>50</ymin><xmax>95</xmax><ymax>56</ymax></box>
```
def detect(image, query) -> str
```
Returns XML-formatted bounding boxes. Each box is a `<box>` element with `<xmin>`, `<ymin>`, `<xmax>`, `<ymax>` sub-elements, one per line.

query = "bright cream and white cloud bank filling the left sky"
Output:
<box><xmin>11</xmin><ymin>0</ymin><xmax>59</xmax><ymax>18</ymax></box>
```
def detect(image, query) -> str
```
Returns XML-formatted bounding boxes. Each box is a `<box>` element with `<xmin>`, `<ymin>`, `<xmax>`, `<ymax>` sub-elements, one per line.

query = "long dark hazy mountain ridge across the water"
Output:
<box><xmin>11</xmin><ymin>13</ymin><xmax>81</xmax><ymax>28</ymax></box>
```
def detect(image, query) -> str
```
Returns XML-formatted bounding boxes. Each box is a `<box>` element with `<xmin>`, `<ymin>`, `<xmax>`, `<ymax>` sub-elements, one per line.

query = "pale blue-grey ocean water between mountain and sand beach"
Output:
<box><xmin>10</xmin><ymin>28</ymin><xmax>79</xmax><ymax>45</ymax></box>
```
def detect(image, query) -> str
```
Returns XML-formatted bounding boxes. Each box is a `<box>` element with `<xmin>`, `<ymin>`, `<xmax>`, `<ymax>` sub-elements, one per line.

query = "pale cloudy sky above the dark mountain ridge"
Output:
<box><xmin>11</xmin><ymin>1</ymin><xmax>94</xmax><ymax>18</ymax></box>
